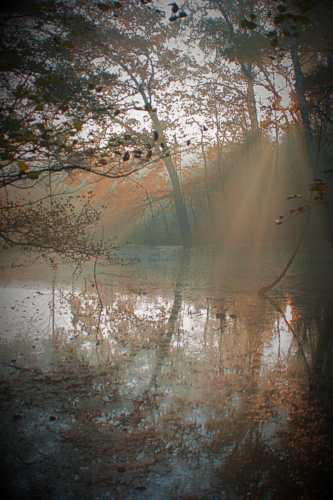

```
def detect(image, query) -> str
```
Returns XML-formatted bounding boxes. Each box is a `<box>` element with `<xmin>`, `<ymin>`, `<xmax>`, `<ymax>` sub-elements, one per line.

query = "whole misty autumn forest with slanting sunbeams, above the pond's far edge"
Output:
<box><xmin>0</xmin><ymin>0</ymin><xmax>333</xmax><ymax>260</ymax></box>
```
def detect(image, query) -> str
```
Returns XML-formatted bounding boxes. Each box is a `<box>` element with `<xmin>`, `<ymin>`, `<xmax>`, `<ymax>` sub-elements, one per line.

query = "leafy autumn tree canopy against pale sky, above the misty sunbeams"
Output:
<box><xmin>0</xmin><ymin>0</ymin><xmax>333</xmax><ymax>250</ymax></box>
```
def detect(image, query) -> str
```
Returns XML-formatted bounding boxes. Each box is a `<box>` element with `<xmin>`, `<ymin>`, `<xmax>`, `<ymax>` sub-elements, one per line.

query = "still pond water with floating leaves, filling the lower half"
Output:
<box><xmin>0</xmin><ymin>247</ymin><xmax>333</xmax><ymax>499</ymax></box>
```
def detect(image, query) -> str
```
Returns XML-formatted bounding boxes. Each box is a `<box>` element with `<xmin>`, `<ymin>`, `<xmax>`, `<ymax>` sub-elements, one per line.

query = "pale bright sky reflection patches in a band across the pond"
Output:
<box><xmin>0</xmin><ymin>285</ymin><xmax>308</xmax><ymax>380</ymax></box>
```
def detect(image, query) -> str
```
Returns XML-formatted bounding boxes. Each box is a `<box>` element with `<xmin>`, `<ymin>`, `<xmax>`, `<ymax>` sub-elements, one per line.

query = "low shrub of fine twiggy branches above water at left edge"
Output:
<box><xmin>0</xmin><ymin>192</ymin><xmax>114</xmax><ymax>266</ymax></box>
